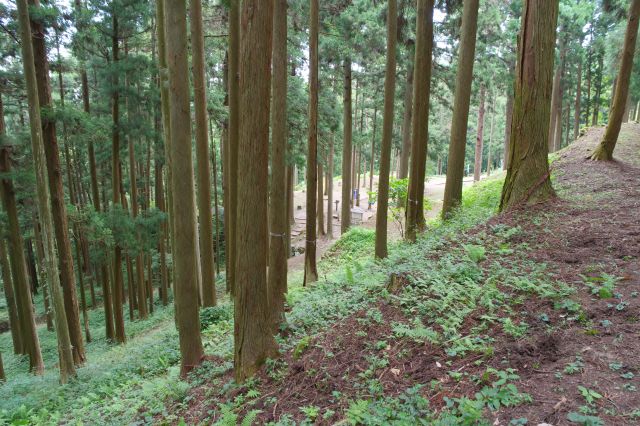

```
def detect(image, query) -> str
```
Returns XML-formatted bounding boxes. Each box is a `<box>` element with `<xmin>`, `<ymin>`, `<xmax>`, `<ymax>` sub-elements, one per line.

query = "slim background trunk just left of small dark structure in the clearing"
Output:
<box><xmin>340</xmin><ymin>58</ymin><xmax>353</xmax><ymax>234</ymax></box>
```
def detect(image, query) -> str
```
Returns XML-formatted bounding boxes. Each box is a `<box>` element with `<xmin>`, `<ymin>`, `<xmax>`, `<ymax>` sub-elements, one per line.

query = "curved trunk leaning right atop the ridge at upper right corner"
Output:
<box><xmin>591</xmin><ymin>0</ymin><xmax>640</xmax><ymax>160</ymax></box>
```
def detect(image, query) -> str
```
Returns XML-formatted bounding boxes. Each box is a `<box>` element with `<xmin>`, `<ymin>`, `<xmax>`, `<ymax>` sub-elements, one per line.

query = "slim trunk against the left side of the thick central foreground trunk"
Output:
<box><xmin>225</xmin><ymin>0</ymin><xmax>241</xmax><ymax>295</ymax></box>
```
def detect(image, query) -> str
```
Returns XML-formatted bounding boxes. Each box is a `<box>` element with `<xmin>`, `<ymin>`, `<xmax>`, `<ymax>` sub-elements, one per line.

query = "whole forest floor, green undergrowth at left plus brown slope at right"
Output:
<box><xmin>0</xmin><ymin>124</ymin><xmax>640</xmax><ymax>425</ymax></box>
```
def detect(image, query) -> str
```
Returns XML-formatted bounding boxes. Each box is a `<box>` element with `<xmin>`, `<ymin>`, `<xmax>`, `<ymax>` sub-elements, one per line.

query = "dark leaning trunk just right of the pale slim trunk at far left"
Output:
<box><xmin>29</xmin><ymin>0</ymin><xmax>86</xmax><ymax>365</ymax></box>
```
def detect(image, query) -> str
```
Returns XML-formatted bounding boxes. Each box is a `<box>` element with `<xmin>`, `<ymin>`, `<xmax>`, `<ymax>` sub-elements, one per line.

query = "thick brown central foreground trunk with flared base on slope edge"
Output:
<box><xmin>234</xmin><ymin>0</ymin><xmax>276</xmax><ymax>383</ymax></box>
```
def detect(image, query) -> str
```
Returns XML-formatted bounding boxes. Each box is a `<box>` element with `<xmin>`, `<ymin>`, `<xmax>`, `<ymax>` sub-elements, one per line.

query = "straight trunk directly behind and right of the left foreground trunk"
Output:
<box><xmin>189</xmin><ymin>0</ymin><xmax>216</xmax><ymax>306</ymax></box>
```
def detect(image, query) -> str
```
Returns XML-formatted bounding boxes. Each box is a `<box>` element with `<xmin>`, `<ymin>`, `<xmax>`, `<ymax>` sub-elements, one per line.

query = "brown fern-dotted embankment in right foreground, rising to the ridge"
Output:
<box><xmin>178</xmin><ymin>124</ymin><xmax>640</xmax><ymax>425</ymax></box>
